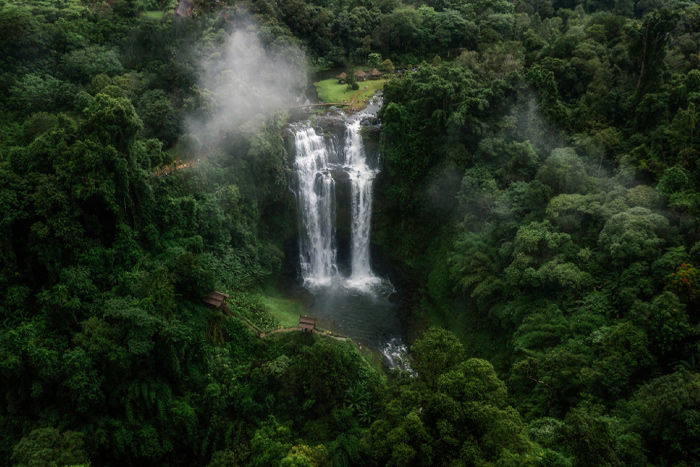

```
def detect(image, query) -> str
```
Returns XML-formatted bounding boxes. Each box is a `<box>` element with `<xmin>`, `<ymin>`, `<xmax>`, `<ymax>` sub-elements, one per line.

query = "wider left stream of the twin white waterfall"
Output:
<box><xmin>294</xmin><ymin>128</ymin><xmax>338</xmax><ymax>285</ymax></box>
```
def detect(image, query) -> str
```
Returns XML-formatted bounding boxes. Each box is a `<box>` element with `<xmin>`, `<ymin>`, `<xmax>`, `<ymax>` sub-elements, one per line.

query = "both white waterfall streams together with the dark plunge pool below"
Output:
<box><xmin>294</xmin><ymin>98</ymin><xmax>406</xmax><ymax>368</ymax></box>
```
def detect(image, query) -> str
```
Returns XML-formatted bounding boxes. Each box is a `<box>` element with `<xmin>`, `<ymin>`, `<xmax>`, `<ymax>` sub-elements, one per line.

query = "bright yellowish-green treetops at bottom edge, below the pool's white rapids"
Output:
<box><xmin>363</xmin><ymin>329</ymin><xmax>530</xmax><ymax>465</ymax></box>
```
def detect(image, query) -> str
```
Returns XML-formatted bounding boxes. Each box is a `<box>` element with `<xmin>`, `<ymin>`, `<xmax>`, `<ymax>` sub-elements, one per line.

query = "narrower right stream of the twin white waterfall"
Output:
<box><xmin>345</xmin><ymin>119</ymin><xmax>376</xmax><ymax>286</ymax></box>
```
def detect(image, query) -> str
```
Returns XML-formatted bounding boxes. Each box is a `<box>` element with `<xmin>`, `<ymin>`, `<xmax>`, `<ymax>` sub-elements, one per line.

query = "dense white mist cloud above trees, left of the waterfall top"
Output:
<box><xmin>187</xmin><ymin>25</ymin><xmax>307</xmax><ymax>148</ymax></box>
